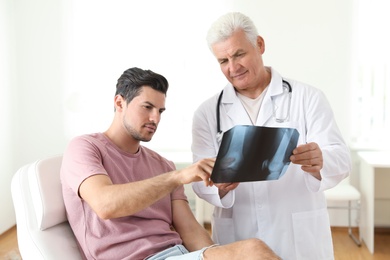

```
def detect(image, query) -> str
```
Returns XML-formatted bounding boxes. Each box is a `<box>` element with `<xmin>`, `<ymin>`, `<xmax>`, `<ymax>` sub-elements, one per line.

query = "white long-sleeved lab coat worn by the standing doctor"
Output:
<box><xmin>192</xmin><ymin>69</ymin><xmax>351</xmax><ymax>260</ymax></box>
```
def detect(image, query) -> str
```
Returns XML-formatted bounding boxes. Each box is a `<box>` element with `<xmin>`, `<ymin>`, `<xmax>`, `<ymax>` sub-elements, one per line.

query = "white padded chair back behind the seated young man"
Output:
<box><xmin>11</xmin><ymin>155</ymin><xmax>83</xmax><ymax>260</ymax></box>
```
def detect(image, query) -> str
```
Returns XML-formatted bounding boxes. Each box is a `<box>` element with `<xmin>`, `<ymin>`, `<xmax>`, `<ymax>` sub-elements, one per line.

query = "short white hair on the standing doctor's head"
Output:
<box><xmin>206</xmin><ymin>12</ymin><xmax>258</xmax><ymax>51</ymax></box>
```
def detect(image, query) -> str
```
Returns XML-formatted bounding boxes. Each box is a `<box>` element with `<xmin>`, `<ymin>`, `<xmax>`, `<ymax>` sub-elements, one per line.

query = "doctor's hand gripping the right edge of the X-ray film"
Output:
<box><xmin>290</xmin><ymin>143</ymin><xmax>323</xmax><ymax>180</ymax></box>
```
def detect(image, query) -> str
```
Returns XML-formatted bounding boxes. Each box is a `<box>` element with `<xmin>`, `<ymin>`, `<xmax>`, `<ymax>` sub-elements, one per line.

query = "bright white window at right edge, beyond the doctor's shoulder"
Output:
<box><xmin>352</xmin><ymin>0</ymin><xmax>390</xmax><ymax>148</ymax></box>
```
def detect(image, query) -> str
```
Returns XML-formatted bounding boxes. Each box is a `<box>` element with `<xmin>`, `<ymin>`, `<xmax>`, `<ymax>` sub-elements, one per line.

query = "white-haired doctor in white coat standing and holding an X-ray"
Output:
<box><xmin>192</xmin><ymin>13</ymin><xmax>351</xmax><ymax>260</ymax></box>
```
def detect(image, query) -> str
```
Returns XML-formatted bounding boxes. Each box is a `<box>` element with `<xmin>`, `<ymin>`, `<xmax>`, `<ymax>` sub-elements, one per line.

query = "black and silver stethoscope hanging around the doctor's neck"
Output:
<box><xmin>217</xmin><ymin>79</ymin><xmax>292</xmax><ymax>142</ymax></box>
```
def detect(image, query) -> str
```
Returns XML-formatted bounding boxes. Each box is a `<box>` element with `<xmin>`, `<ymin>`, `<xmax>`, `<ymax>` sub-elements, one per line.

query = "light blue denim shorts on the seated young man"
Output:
<box><xmin>145</xmin><ymin>245</ymin><xmax>213</xmax><ymax>260</ymax></box>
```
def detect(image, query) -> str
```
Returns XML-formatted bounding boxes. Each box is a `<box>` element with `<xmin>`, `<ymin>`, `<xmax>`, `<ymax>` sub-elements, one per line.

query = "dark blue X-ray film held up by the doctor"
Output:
<box><xmin>211</xmin><ymin>125</ymin><xmax>299</xmax><ymax>183</ymax></box>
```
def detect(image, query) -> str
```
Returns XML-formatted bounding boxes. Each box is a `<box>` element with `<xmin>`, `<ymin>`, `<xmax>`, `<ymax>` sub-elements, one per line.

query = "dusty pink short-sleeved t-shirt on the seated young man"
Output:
<box><xmin>61</xmin><ymin>133</ymin><xmax>187</xmax><ymax>260</ymax></box>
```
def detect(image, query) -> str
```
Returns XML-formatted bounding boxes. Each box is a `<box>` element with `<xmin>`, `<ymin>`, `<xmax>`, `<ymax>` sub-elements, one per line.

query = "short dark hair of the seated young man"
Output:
<box><xmin>115</xmin><ymin>67</ymin><xmax>169</xmax><ymax>103</ymax></box>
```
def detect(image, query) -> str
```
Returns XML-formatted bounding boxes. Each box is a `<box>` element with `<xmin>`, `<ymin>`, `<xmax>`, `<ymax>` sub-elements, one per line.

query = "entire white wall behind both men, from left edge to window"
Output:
<box><xmin>0</xmin><ymin>0</ymin><xmax>360</xmax><ymax>233</ymax></box>
